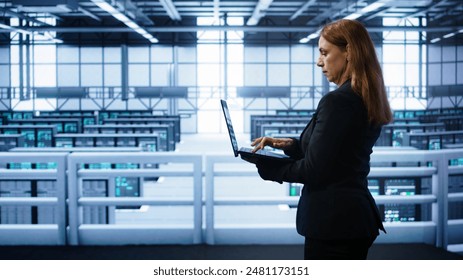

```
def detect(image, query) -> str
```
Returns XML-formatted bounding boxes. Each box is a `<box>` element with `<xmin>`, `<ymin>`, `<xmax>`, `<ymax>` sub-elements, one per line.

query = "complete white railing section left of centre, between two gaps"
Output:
<box><xmin>68</xmin><ymin>152</ymin><xmax>203</xmax><ymax>245</ymax></box>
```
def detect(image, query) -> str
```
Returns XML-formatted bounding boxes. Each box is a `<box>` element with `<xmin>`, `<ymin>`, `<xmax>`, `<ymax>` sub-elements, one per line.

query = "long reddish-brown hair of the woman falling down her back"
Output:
<box><xmin>320</xmin><ymin>19</ymin><xmax>392</xmax><ymax>125</ymax></box>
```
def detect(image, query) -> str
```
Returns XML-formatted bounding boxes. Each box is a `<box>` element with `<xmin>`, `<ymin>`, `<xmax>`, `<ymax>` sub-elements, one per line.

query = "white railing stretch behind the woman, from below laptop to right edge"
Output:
<box><xmin>205</xmin><ymin>149</ymin><xmax>463</xmax><ymax>248</ymax></box>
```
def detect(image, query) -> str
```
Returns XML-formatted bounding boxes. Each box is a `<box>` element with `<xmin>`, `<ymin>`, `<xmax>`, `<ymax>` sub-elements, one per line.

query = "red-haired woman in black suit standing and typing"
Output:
<box><xmin>252</xmin><ymin>19</ymin><xmax>392</xmax><ymax>259</ymax></box>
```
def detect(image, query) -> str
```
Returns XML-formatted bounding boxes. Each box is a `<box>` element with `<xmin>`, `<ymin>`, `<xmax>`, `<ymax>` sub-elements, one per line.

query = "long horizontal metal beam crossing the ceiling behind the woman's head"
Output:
<box><xmin>0</xmin><ymin>26</ymin><xmax>461</xmax><ymax>33</ymax></box>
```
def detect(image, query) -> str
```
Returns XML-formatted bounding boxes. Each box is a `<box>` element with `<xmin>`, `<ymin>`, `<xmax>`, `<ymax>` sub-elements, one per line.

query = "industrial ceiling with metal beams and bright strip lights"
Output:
<box><xmin>0</xmin><ymin>0</ymin><xmax>463</xmax><ymax>44</ymax></box>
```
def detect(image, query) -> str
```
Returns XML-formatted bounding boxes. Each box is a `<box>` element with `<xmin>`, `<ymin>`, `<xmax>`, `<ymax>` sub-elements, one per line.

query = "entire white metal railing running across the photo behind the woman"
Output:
<box><xmin>0</xmin><ymin>149</ymin><xmax>463</xmax><ymax>252</ymax></box>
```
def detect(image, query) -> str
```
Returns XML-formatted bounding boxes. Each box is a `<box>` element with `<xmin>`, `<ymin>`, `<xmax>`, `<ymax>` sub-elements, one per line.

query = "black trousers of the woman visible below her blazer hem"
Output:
<box><xmin>304</xmin><ymin>236</ymin><xmax>376</xmax><ymax>260</ymax></box>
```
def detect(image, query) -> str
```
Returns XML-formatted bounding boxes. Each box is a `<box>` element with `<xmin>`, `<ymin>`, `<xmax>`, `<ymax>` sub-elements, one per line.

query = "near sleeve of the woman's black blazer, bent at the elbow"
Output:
<box><xmin>275</xmin><ymin>93</ymin><xmax>358</xmax><ymax>186</ymax></box>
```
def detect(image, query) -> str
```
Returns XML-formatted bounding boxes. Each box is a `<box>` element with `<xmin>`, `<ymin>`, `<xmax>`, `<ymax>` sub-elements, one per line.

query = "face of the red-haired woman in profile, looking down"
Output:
<box><xmin>317</xmin><ymin>36</ymin><xmax>347</xmax><ymax>86</ymax></box>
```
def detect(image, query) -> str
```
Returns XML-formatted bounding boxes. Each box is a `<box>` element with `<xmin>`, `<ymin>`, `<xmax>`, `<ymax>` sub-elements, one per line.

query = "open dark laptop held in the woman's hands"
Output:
<box><xmin>220</xmin><ymin>99</ymin><xmax>294</xmax><ymax>163</ymax></box>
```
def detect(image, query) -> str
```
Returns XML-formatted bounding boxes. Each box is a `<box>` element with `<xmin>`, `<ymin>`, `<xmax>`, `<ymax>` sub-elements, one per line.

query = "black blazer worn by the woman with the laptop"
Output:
<box><xmin>264</xmin><ymin>81</ymin><xmax>384</xmax><ymax>239</ymax></box>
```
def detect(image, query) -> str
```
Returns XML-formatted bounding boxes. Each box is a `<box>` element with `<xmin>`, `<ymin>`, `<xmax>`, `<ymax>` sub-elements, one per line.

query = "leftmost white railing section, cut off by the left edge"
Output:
<box><xmin>0</xmin><ymin>153</ymin><xmax>67</xmax><ymax>245</ymax></box>
